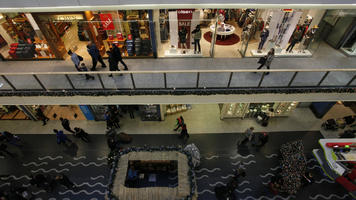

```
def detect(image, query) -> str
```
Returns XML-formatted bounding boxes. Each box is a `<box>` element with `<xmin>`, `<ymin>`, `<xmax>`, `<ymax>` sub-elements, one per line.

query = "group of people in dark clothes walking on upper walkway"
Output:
<box><xmin>68</xmin><ymin>42</ymin><xmax>128</xmax><ymax>80</ymax></box>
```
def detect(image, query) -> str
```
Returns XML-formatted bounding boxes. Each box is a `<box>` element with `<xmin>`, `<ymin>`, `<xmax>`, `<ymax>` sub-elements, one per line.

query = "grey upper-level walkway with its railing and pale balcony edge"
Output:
<box><xmin>0</xmin><ymin>44</ymin><xmax>356</xmax><ymax>104</ymax></box>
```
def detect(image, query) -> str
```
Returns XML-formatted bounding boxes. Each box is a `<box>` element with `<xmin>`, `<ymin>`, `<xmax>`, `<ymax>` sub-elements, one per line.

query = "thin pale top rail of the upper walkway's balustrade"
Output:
<box><xmin>0</xmin><ymin>68</ymin><xmax>356</xmax><ymax>76</ymax></box>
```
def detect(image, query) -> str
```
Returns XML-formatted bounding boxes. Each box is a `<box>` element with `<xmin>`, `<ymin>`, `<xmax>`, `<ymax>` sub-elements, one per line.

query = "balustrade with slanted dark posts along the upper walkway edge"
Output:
<box><xmin>0</xmin><ymin>68</ymin><xmax>356</xmax><ymax>91</ymax></box>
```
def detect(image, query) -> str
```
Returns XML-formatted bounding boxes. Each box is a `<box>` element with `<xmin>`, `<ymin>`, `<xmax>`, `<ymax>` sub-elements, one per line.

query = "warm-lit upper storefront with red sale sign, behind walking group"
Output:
<box><xmin>29</xmin><ymin>10</ymin><xmax>153</xmax><ymax>59</ymax></box>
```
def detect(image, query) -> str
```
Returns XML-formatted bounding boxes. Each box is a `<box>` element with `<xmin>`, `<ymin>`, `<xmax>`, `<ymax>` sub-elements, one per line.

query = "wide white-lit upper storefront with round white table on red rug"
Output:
<box><xmin>158</xmin><ymin>9</ymin><xmax>325</xmax><ymax>57</ymax></box>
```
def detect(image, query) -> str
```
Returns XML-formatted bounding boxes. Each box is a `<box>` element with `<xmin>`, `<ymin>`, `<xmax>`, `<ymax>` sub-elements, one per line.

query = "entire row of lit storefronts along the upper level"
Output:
<box><xmin>0</xmin><ymin>9</ymin><xmax>350</xmax><ymax>59</ymax></box>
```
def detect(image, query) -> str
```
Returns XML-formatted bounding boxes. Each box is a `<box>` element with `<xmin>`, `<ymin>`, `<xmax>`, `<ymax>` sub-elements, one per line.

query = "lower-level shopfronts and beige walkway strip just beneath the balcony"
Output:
<box><xmin>0</xmin><ymin>102</ymin><xmax>356</xmax><ymax>138</ymax></box>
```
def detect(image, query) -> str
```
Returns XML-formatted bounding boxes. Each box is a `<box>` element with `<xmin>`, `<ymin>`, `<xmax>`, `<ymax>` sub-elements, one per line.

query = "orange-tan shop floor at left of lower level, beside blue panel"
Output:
<box><xmin>44</xmin><ymin>105</ymin><xmax>86</xmax><ymax>120</ymax></box>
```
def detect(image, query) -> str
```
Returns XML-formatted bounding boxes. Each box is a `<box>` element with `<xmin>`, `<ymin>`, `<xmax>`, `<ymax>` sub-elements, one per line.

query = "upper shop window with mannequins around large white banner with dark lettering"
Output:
<box><xmin>248</xmin><ymin>9</ymin><xmax>325</xmax><ymax>57</ymax></box>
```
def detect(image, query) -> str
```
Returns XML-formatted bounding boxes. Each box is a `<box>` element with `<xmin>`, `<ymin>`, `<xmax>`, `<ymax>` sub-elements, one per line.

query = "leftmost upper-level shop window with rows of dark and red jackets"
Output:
<box><xmin>0</xmin><ymin>13</ymin><xmax>55</xmax><ymax>60</ymax></box>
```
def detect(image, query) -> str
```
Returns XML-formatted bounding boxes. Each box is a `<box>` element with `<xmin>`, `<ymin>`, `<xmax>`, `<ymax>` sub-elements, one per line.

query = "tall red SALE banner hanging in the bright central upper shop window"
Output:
<box><xmin>177</xmin><ymin>9</ymin><xmax>194</xmax><ymax>49</ymax></box>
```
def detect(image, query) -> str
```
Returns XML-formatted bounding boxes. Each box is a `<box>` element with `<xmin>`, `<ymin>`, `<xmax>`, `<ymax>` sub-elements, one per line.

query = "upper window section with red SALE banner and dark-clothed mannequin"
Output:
<box><xmin>159</xmin><ymin>9</ymin><xmax>217</xmax><ymax>57</ymax></box>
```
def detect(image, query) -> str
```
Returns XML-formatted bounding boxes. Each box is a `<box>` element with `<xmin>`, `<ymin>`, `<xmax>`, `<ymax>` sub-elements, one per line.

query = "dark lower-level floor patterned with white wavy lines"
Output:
<box><xmin>0</xmin><ymin>132</ymin><xmax>352</xmax><ymax>200</ymax></box>
